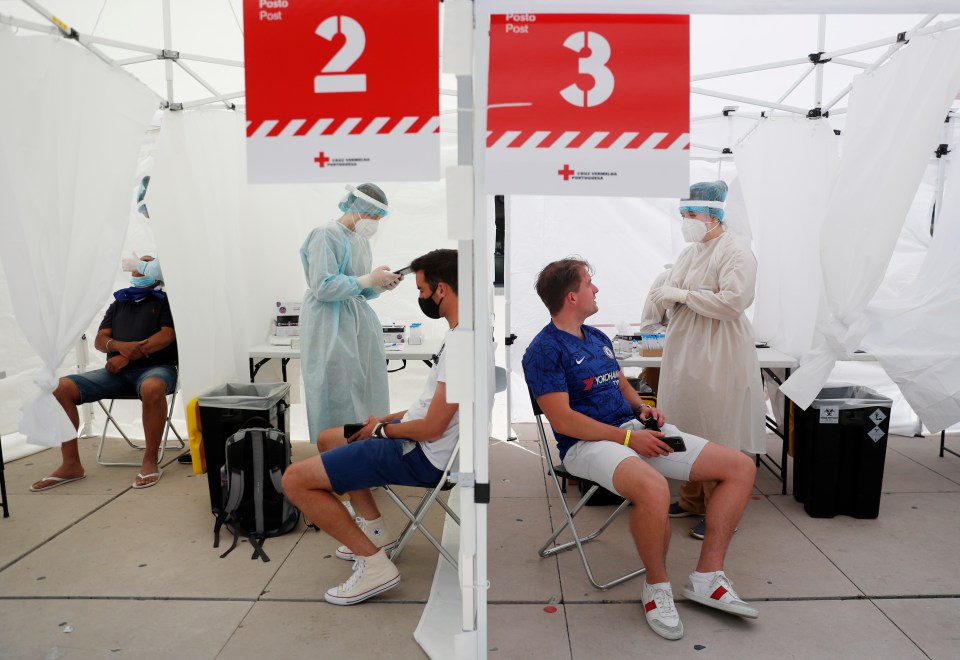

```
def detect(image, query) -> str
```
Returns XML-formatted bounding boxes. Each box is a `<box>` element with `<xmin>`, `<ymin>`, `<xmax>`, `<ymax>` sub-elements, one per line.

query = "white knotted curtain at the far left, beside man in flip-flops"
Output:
<box><xmin>0</xmin><ymin>28</ymin><xmax>158</xmax><ymax>446</ymax></box>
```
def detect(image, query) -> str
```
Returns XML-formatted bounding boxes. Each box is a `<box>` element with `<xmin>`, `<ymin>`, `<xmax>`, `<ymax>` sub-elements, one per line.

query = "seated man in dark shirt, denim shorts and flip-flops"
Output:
<box><xmin>30</xmin><ymin>257</ymin><xmax>177</xmax><ymax>492</ymax></box>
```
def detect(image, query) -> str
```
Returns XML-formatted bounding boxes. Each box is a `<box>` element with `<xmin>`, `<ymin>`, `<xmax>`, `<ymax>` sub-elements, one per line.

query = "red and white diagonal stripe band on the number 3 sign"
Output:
<box><xmin>487</xmin><ymin>131</ymin><xmax>690</xmax><ymax>151</ymax></box>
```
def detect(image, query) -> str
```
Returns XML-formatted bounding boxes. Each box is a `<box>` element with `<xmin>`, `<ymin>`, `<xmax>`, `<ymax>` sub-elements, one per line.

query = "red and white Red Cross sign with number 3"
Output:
<box><xmin>487</xmin><ymin>14</ymin><xmax>690</xmax><ymax>197</ymax></box>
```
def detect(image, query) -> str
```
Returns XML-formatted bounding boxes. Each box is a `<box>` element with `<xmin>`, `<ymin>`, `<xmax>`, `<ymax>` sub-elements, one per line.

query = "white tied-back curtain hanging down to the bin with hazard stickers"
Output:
<box><xmin>782</xmin><ymin>31</ymin><xmax>960</xmax><ymax>408</ymax></box>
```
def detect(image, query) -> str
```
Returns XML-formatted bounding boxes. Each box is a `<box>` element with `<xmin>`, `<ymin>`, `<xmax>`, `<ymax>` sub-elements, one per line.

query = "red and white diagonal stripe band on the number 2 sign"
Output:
<box><xmin>247</xmin><ymin>115</ymin><xmax>440</xmax><ymax>137</ymax></box>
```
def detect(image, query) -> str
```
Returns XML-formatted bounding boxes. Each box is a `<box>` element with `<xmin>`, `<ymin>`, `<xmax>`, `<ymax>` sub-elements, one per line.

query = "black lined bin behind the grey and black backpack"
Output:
<box><xmin>197</xmin><ymin>383</ymin><xmax>290</xmax><ymax>514</ymax></box>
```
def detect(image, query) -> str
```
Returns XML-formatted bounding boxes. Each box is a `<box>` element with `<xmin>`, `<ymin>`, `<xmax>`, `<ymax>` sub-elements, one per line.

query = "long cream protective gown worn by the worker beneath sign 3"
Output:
<box><xmin>657</xmin><ymin>233</ymin><xmax>766</xmax><ymax>454</ymax></box>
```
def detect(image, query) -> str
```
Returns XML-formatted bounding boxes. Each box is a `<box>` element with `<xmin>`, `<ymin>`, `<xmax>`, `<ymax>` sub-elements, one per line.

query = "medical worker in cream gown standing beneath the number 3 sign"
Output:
<box><xmin>649</xmin><ymin>181</ymin><xmax>766</xmax><ymax>539</ymax></box>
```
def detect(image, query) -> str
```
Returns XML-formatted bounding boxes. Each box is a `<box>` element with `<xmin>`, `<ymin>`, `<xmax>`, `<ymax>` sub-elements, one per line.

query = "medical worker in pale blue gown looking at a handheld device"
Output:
<box><xmin>300</xmin><ymin>183</ymin><xmax>401</xmax><ymax>442</ymax></box>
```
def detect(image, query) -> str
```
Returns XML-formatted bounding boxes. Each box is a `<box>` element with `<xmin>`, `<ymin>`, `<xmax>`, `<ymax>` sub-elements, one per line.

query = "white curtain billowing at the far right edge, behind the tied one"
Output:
<box><xmin>864</xmin><ymin>131</ymin><xmax>960</xmax><ymax>432</ymax></box>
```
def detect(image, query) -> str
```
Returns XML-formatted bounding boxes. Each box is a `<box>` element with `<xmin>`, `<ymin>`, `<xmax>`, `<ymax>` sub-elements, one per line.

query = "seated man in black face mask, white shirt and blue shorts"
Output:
<box><xmin>283</xmin><ymin>250</ymin><xmax>478</xmax><ymax>605</ymax></box>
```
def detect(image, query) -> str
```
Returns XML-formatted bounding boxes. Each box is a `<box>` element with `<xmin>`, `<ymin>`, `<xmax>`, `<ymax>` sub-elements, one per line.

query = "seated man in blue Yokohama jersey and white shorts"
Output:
<box><xmin>523</xmin><ymin>258</ymin><xmax>758</xmax><ymax>639</ymax></box>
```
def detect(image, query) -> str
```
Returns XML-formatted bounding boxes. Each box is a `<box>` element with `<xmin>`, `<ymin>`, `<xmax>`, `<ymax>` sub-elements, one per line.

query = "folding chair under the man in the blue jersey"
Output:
<box><xmin>530</xmin><ymin>393</ymin><xmax>647</xmax><ymax>591</ymax></box>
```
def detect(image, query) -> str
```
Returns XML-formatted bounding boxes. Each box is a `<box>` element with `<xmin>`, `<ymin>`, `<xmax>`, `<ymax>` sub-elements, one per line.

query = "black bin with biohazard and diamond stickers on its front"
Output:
<box><xmin>793</xmin><ymin>385</ymin><xmax>893</xmax><ymax>518</ymax></box>
